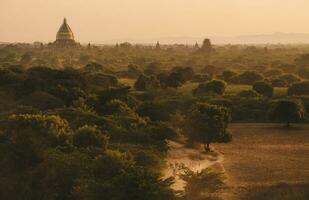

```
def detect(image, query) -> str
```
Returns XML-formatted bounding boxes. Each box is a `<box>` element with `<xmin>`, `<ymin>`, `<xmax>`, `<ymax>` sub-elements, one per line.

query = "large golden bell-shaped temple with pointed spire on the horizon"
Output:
<box><xmin>53</xmin><ymin>18</ymin><xmax>80</xmax><ymax>48</ymax></box>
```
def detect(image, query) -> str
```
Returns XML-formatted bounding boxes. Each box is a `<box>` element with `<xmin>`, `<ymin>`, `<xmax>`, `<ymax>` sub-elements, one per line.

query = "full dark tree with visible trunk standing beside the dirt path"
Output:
<box><xmin>186</xmin><ymin>103</ymin><xmax>231</xmax><ymax>152</ymax></box>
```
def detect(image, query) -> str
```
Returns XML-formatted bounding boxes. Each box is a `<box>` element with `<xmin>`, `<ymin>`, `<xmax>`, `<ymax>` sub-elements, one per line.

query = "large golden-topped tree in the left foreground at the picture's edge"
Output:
<box><xmin>2</xmin><ymin>114</ymin><xmax>72</xmax><ymax>170</ymax></box>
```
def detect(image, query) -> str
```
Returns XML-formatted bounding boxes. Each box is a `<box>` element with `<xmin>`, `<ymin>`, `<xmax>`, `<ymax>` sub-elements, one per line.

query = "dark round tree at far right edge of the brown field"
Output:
<box><xmin>270</xmin><ymin>100</ymin><xmax>304</xmax><ymax>127</ymax></box>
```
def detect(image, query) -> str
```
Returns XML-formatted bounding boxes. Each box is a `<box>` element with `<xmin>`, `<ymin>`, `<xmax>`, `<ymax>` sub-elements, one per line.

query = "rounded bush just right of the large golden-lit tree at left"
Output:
<box><xmin>73</xmin><ymin>125</ymin><xmax>108</xmax><ymax>150</ymax></box>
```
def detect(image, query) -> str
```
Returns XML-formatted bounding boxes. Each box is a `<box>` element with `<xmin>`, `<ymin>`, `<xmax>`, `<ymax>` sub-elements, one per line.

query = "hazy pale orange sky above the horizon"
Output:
<box><xmin>0</xmin><ymin>0</ymin><xmax>309</xmax><ymax>42</ymax></box>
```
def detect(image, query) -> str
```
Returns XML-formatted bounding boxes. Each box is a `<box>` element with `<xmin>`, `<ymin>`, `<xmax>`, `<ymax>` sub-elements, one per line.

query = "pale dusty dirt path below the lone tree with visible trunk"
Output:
<box><xmin>163</xmin><ymin>141</ymin><xmax>224</xmax><ymax>191</ymax></box>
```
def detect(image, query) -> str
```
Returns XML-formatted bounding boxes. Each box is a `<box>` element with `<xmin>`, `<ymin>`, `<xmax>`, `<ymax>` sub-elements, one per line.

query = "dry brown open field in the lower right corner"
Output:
<box><xmin>215</xmin><ymin>124</ymin><xmax>309</xmax><ymax>200</ymax></box>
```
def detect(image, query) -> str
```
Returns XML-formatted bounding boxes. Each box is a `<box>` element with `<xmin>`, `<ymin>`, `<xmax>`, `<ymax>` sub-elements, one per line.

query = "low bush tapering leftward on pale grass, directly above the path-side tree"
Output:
<box><xmin>192</xmin><ymin>80</ymin><xmax>226</xmax><ymax>95</ymax></box>
